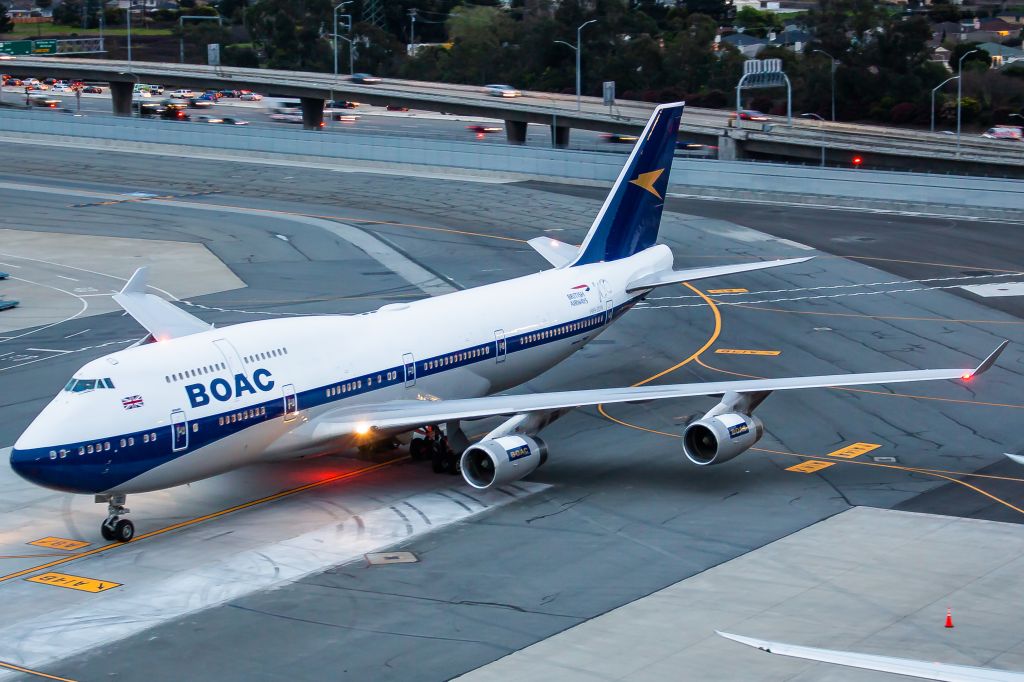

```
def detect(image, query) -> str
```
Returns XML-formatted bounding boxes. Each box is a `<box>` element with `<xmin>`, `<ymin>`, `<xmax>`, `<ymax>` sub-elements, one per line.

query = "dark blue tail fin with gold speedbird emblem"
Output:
<box><xmin>570</xmin><ymin>101</ymin><xmax>684</xmax><ymax>267</ymax></box>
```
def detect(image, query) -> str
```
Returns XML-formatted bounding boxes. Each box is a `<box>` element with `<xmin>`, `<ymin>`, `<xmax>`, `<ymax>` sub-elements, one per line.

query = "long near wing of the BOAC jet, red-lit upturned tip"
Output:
<box><xmin>314</xmin><ymin>341</ymin><xmax>1009</xmax><ymax>438</ymax></box>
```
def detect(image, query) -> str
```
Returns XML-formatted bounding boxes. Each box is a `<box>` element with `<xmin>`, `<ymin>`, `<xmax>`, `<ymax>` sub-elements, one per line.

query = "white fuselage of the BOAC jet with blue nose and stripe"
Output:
<box><xmin>15</xmin><ymin>246</ymin><xmax>672</xmax><ymax>494</ymax></box>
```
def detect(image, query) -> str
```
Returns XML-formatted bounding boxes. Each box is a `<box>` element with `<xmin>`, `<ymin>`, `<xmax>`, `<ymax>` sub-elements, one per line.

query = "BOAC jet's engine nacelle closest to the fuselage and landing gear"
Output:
<box><xmin>462</xmin><ymin>435</ymin><xmax>548</xmax><ymax>491</ymax></box>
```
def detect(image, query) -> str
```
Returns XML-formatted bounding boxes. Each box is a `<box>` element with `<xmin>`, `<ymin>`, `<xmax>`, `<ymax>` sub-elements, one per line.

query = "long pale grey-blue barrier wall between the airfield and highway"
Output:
<box><xmin>0</xmin><ymin>110</ymin><xmax>1024</xmax><ymax>210</ymax></box>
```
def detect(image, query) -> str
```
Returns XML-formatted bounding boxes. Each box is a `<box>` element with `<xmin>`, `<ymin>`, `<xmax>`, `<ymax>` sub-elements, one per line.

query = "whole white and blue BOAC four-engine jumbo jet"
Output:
<box><xmin>10</xmin><ymin>102</ymin><xmax>1006</xmax><ymax>542</ymax></box>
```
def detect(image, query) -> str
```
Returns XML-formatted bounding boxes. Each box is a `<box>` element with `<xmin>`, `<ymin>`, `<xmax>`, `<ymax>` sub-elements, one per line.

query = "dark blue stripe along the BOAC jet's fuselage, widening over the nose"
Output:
<box><xmin>11</xmin><ymin>299</ymin><xmax>638</xmax><ymax>493</ymax></box>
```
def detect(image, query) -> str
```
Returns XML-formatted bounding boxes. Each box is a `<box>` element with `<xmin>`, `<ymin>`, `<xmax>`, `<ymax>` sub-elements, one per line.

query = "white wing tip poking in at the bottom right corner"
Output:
<box><xmin>715</xmin><ymin>630</ymin><xmax>1024</xmax><ymax>682</ymax></box>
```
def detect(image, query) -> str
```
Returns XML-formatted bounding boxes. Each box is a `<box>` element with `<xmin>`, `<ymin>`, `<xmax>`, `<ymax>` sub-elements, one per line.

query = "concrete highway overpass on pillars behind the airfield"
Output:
<box><xmin>0</xmin><ymin>57</ymin><xmax>1024</xmax><ymax>177</ymax></box>
